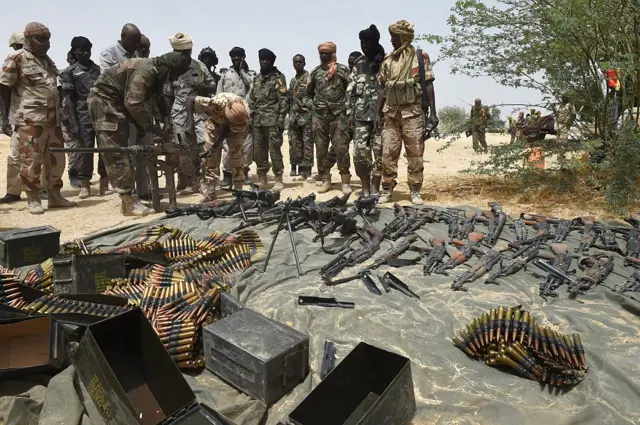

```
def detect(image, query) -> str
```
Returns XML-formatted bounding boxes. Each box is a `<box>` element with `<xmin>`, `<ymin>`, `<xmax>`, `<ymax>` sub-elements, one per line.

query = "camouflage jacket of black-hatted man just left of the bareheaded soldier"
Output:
<box><xmin>247</xmin><ymin>67</ymin><xmax>287</xmax><ymax>127</ymax></box>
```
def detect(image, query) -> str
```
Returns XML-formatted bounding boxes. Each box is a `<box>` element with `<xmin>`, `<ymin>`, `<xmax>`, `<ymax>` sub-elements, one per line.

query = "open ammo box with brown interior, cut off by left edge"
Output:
<box><xmin>0</xmin><ymin>315</ymin><xmax>69</xmax><ymax>379</ymax></box>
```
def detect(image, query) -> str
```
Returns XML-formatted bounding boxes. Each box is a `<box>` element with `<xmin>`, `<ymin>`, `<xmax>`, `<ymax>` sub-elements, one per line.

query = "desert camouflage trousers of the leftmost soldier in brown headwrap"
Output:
<box><xmin>11</xmin><ymin>125</ymin><xmax>65</xmax><ymax>192</ymax></box>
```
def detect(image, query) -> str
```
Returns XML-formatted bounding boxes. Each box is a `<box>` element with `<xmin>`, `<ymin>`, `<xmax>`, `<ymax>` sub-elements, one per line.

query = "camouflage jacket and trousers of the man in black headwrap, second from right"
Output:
<box><xmin>347</xmin><ymin>56</ymin><xmax>382</xmax><ymax>178</ymax></box>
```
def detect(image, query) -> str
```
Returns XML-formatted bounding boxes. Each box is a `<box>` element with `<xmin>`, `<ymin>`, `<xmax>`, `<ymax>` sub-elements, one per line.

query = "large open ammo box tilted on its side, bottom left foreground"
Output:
<box><xmin>73</xmin><ymin>309</ymin><xmax>233</xmax><ymax>425</ymax></box>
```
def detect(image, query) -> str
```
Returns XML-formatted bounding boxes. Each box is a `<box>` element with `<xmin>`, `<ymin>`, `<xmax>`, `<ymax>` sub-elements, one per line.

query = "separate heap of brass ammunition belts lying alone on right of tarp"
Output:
<box><xmin>453</xmin><ymin>306</ymin><xmax>588</xmax><ymax>387</ymax></box>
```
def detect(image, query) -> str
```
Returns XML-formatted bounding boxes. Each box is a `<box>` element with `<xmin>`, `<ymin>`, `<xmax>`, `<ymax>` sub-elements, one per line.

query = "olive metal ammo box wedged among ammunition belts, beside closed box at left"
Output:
<box><xmin>53</xmin><ymin>254</ymin><xmax>127</xmax><ymax>294</ymax></box>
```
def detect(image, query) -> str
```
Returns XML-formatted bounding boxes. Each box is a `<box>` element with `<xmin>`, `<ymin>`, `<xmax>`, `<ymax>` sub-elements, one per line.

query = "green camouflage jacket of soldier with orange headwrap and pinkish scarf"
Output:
<box><xmin>307</xmin><ymin>64</ymin><xmax>349</xmax><ymax>115</ymax></box>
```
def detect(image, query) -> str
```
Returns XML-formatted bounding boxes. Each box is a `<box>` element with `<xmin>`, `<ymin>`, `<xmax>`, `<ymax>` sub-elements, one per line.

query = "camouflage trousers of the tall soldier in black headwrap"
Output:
<box><xmin>353</xmin><ymin>121</ymin><xmax>382</xmax><ymax>177</ymax></box>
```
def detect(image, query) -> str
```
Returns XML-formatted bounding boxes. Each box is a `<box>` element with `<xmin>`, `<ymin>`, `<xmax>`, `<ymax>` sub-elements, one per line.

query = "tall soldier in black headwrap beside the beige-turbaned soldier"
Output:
<box><xmin>347</xmin><ymin>25</ymin><xmax>385</xmax><ymax>196</ymax></box>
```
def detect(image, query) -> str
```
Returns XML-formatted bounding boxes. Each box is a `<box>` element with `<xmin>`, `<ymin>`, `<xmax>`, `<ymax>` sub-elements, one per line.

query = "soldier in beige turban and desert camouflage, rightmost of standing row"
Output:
<box><xmin>377</xmin><ymin>20</ymin><xmax>438</xmax><ymax>205</ymax></box>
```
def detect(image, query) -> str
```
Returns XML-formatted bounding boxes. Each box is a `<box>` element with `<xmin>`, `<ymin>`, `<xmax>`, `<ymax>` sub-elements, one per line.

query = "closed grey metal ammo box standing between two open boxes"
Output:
<box><xmin>203</xmin><ymin>309</ymin><xmax>309</xmax><ymax>405</ymax></box>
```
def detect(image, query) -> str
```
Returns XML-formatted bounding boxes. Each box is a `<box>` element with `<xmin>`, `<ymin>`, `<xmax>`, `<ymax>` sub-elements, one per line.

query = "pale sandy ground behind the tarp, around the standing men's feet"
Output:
<box><xmin>0</xmin><ymin>131</ymin><xmax>552</xmax><ymax>241</ymax></box>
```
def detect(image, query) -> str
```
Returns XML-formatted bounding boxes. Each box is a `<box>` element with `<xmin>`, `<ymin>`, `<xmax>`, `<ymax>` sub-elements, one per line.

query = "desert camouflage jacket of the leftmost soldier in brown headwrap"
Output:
<box><xmin>0</xmin><ymin>49</ymin><xmax>61</xmax><ymax>127</ymax></box>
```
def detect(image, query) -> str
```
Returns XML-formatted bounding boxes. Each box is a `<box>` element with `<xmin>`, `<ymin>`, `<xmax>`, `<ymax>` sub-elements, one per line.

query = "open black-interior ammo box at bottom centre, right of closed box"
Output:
<box><xmin>289</xmin><ymin>342</ymin><xmax>416</xmax><ymax>425</ymax></box>
